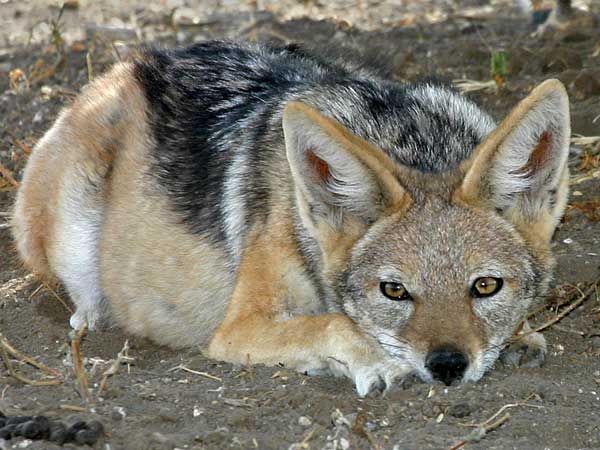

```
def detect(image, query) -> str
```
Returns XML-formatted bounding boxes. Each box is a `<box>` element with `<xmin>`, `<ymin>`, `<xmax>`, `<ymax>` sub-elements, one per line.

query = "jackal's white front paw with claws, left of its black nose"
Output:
<box><xmin>329</xmin><ymin>358</ymin><xmax>411</xmax><ymax>397</ymax></box>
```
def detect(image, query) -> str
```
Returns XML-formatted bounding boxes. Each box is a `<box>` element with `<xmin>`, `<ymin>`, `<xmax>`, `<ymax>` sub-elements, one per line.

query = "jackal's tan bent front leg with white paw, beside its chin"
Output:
<box><xmin>208</xmin><ymin>230</ymin><xmax>409</xmax><ymax>396</ymax></box>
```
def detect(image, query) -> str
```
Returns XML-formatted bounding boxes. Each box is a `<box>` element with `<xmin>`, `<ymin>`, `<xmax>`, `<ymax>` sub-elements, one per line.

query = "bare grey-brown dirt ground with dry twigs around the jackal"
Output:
<box><xmin>0</xmin><ymin>0</ymin><xmax>600</xmax><ymax>449</ymax></box>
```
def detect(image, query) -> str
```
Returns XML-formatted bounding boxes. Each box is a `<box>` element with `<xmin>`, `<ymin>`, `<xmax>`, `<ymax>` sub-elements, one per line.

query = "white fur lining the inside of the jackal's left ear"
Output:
<box><xmin>283</xmin><ymin>104</ymin><xmax>392</xmax><ymax>224</ymax></box>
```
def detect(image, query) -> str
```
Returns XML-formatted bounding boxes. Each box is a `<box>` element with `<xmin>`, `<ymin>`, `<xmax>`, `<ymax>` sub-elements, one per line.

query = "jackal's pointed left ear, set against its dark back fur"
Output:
<box><xmin>283</xmin><ymin>102</ymin><xmax>408</xmax><ymax>228</ymax></box>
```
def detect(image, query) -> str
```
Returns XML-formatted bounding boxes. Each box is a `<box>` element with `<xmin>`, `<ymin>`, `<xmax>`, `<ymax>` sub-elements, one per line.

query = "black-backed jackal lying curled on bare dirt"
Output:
<box><xmin>13</xmin><ymin>42</ymin><xmax>570</xmax><ymax>395</ymax></box>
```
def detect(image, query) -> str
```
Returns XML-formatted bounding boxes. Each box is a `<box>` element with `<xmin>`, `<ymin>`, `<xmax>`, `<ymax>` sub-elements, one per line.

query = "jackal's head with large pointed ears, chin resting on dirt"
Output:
<box><xmin>283</xmin><ymin>80</ymin><xmax>570</xmax><ymax>383</ymax></box>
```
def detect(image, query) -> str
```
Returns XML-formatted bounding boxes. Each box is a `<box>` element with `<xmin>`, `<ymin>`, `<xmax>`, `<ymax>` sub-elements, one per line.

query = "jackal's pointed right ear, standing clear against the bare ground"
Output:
<box><xmin>455</xmin><ymin>80</ymin><xmax>571</xmax><ymax>243</ymax></box>
